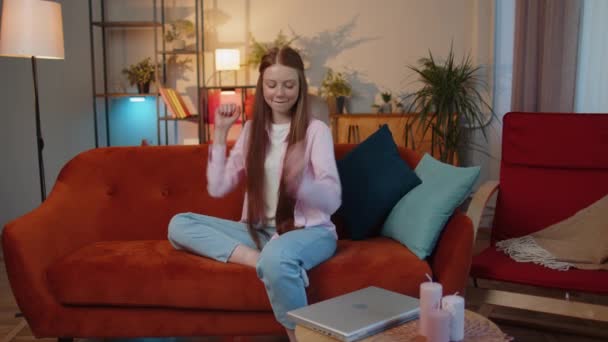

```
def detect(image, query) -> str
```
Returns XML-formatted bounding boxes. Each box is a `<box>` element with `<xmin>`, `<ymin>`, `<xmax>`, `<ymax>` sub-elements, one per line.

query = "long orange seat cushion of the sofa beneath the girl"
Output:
<box><xmin>47</xmin><ymin>238</ymin><xmax>431</xmax><ymax>311</ymax></box>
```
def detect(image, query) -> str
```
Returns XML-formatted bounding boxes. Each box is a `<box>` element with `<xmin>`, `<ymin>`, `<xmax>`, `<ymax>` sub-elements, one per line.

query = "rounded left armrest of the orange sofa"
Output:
<box><xmin>2</xmin><ymin>184</ymin><xmax>101</xmax><ymax>335</ymax></box>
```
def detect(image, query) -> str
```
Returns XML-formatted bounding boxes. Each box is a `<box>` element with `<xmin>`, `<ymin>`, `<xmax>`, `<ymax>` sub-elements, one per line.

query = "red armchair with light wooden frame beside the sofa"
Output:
<box><xmin>467</xmin><ymin>113</ymin><xmax>608</xmax><ymax>321</ymax></box>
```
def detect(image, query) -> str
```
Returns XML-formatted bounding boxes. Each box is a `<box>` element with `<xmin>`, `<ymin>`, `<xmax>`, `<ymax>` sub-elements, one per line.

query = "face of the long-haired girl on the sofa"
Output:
<box><xmin>262</xmin><ymin>64</ymin><xmax>300</xmax><ymax>117</ymax></box>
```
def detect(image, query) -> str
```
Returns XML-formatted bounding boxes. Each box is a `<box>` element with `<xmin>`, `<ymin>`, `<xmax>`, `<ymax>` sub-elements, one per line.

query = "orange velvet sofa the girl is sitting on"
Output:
<box><xmin>2</xmin><ymin>145</ymin><xmax>473</xmax><ymax>338</ymax></box>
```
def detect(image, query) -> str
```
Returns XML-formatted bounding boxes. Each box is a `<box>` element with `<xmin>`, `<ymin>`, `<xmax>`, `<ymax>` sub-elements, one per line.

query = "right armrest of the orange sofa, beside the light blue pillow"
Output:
<box><xmin>430</xmin><ymin>211</ymin><xmax>475</xmax><ymax>295</ymax></box>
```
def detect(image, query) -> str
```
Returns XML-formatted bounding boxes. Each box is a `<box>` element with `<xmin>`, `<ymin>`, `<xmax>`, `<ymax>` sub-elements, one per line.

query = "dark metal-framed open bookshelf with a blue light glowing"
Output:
<box><xmin>89</xmin><ymin>0</ymin><xmax>207</xmax><ymax>147</ymax></box>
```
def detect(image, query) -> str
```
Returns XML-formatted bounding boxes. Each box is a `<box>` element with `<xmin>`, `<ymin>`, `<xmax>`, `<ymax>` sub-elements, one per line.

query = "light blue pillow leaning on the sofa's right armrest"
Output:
<box><xmin>381</xmin><ymin>154</ymin><xmax>480</xmax><ymax>259</ymax></box>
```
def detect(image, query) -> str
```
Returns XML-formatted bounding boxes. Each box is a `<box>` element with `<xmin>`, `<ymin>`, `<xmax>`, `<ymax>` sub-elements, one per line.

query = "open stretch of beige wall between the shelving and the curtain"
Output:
<box><xmin>205</xmin><ymin>0</ymin><xmax>493</xmax><ymax>113</ymax></box>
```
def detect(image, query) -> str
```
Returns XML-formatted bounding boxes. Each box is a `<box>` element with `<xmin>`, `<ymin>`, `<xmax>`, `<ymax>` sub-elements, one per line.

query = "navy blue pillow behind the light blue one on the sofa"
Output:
<box><xmin>337</xmin><ymin>125</ymin><xmax>422</xmax><ymax>240</ymax></box>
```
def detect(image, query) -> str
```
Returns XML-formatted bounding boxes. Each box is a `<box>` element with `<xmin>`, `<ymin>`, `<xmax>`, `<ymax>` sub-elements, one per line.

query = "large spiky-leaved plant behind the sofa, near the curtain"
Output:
<box><xmin>408</xmin><ymin>48</ymin><xmax>495</xmax><ymax>164</ymax></box>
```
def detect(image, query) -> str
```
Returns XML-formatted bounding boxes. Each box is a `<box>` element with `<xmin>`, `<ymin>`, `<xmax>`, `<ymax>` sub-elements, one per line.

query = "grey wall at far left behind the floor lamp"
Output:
<box><xmin>0</xmin><ymin>0</ymin><xmax>95</xmax><ymax>230</ymax></box>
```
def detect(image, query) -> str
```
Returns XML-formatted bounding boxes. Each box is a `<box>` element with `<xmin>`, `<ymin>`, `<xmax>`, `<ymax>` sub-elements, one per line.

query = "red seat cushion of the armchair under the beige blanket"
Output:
<box><xmin>471</xmin><ymin>246</ymin><xmax>608</xmax><ymax>294</ymax></box>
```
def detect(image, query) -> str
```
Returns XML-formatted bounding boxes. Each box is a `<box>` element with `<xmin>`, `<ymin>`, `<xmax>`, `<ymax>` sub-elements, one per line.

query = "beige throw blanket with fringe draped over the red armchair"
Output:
<box><xmin>496</xmin><ymin>195</ymin><xmax>608</xmax><ymax>271</ymax></box>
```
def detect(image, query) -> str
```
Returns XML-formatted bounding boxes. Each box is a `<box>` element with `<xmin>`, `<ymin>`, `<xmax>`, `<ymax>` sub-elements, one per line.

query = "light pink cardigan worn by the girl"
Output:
<box><xmin>207</xmin><ymin>119</ymin><xmax>342</xmax><ymax>237</ymax></box>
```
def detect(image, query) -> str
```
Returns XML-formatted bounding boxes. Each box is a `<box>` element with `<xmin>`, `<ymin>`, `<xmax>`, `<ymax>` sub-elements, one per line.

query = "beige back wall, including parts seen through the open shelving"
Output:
<box><xmin>96</xmin><ymin>0</ymin><xmax>494</xmax><ymax>154</ymax></box>
